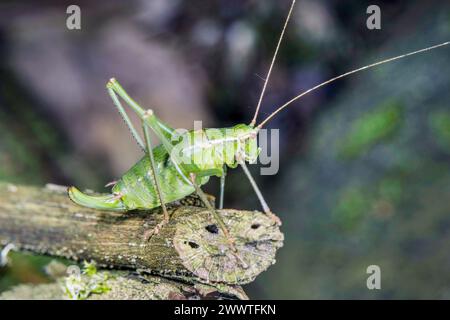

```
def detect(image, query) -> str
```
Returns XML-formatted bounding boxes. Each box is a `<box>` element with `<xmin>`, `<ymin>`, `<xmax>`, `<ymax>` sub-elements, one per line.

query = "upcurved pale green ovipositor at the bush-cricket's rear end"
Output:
<box><xmin>68</xmin><ymin>187</ymin><xmax>126</xmax><ymax>211</ymax></box>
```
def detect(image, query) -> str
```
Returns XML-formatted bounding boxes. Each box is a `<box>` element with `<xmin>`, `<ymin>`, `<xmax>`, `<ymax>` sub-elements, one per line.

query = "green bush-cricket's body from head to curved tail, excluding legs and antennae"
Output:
<box><xmin>69</xmin><ymin>125</ymin><xmax>258</xmax><ymax>211</ymax></box>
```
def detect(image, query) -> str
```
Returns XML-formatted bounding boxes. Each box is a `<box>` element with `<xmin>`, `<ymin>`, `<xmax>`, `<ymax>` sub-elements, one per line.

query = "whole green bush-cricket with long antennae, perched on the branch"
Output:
<box><xmin>68</xmin><ymin>0</ymin><xmax>450</xmax><ymax>246</ymax></box>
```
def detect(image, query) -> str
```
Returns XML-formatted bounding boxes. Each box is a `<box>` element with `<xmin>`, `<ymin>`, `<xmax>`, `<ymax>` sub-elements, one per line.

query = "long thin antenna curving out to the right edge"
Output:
<box><xmin>257</xmin><ymin>41</ymin><xmax>450</xmax><ymax>129</ymax></box>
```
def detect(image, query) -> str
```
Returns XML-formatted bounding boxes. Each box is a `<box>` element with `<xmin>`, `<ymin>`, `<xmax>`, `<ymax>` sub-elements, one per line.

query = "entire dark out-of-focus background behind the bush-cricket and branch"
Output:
<box><xmin>0</xmin><ymin>0</ymin><xmax>450</xmax><ymax>299</ymax></box>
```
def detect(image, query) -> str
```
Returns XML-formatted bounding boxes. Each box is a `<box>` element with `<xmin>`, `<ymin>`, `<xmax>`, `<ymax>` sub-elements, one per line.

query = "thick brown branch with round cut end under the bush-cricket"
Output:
<box><xmin>0</xmin><ymin>184</ymin><xmax>283</xmax><ymax>285</ymax></box>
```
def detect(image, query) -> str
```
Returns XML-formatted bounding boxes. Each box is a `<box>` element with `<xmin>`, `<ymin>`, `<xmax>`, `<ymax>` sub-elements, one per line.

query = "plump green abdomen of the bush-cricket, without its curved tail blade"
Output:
<box><xmin>113</xmin><ymin>147</ymin><xmax>206</xmax><ymax>210</ymax></box>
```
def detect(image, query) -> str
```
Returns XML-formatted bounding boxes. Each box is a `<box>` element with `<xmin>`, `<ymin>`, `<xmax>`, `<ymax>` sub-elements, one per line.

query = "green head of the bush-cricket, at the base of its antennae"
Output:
<box><xmin>233</xmin><ymin>124</ymin><xmax>261</xmax><ymax>163</ymax></box>
